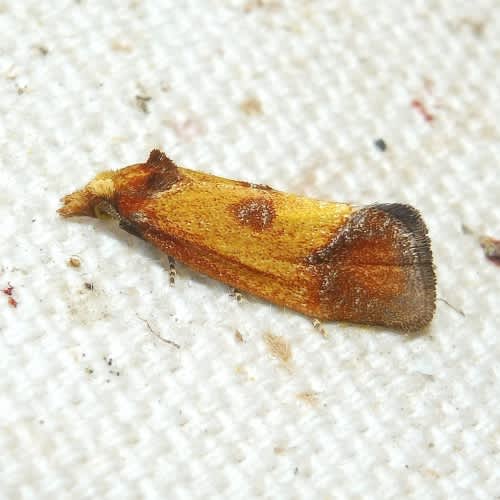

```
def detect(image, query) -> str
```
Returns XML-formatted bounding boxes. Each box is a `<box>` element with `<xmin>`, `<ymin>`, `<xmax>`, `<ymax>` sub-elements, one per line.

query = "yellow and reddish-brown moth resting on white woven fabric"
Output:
<box><xmin>59</xmin><ymin>150</ymin><xmax>436</xmax><ymax>331</ymax></box>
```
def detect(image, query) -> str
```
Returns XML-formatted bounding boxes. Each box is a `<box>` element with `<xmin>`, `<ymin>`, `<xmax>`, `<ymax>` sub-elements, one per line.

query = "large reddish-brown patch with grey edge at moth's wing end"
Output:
<box><xmin>307</xmin><ymin>204</ymin><xmax>436</xmax><ymax>330</ymax></box>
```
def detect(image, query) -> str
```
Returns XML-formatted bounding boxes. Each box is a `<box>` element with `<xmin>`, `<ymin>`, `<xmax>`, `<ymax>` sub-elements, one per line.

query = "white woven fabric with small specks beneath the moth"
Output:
<box><xmin>0</xmin><ymin>0</ymin><xmax>500</xmax><ymax>499</ymax></box>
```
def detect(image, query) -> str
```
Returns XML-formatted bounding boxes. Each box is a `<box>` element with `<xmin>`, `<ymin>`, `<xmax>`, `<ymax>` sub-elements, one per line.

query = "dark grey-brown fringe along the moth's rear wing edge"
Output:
<box><xmin>373</xmin><ymin>203</ymin><xmax>436</xmax><ymax>331</ymax></box>
